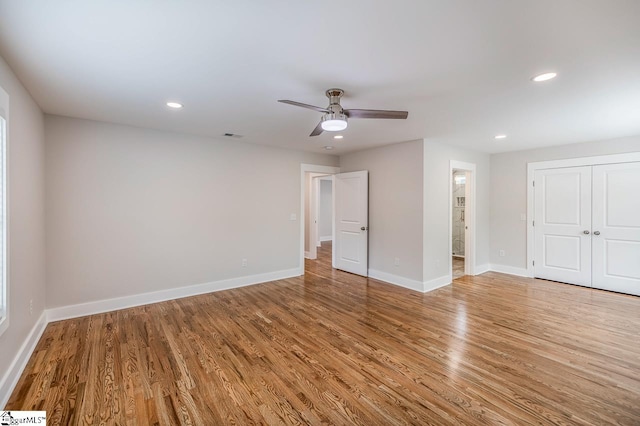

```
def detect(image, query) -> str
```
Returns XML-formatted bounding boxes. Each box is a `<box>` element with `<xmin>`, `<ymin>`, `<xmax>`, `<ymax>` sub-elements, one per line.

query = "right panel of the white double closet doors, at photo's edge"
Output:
<box><xmin>592</xmin><ymin>163</ymin><xmax>640</xmax><ymax>295</ymax></box>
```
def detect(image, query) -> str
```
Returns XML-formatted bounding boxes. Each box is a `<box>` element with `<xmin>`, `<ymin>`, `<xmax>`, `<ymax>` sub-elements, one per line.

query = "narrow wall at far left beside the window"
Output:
<box><xmin>0</xmin><ymin>58</ymin><xmax>45</xmax><ymax>400</ymax></box>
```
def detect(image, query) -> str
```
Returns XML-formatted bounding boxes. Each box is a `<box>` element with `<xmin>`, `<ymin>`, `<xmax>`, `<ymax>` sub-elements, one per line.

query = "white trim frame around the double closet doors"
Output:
<box><xmin>526</xmin><ymin>152</ymin><xmax>640</xmax><ymax>278</ymax></box>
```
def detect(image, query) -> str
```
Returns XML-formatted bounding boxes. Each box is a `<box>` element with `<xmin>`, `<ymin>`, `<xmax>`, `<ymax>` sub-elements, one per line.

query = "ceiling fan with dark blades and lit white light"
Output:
<box><xmin>278</xmin><ymin>89</ymin><xmax>409</xmax><ymax>136</ymax></box>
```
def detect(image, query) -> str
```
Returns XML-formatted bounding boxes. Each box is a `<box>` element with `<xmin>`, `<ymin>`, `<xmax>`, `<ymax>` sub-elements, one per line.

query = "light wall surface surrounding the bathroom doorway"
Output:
<box><xmin>424</xmin><ymin>140</ymin><xmax>490</xmax><ymax>283</ymax></box>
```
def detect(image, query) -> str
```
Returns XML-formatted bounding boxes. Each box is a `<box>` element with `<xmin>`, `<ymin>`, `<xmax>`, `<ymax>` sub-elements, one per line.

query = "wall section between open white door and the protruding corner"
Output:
<box><xmin>340</xmin><ymin>140</ymin><xmax>424</xmax><ymax>283</ymax></box>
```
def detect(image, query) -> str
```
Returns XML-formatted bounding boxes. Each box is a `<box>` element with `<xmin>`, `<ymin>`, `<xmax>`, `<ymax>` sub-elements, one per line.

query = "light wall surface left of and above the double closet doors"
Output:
<box><xmin>490</xmin><ymin>136</ymin><xmax>640</xmax><ymax>273</ymax></box>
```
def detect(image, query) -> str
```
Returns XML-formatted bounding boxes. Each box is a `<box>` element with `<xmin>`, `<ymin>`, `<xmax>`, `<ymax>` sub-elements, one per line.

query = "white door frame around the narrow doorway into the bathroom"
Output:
<box><xmin>448</xmin><ymin>160</ymin><xmax>477</xmax><ymax>281</ymax></box>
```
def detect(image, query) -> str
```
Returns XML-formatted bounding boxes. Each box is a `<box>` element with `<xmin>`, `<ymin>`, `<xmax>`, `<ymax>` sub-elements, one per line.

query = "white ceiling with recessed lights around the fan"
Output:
<box><xmin>0</xmin><ymin>0</ymin><xmax>640</xmax><ymax>154</ymax></box>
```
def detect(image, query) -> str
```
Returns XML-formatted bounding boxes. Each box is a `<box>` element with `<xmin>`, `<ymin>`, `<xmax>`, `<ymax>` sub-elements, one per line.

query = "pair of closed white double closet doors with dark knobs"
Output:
<box><xmin>534</xmin><ymin>162</ymin><xmax>640</xmax><ymax>295</ymax></box>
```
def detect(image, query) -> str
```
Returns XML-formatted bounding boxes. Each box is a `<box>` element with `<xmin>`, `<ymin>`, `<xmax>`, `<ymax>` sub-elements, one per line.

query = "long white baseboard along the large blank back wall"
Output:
<box><xmin>46</xmin><ymin>268</ymin><xmax>300</xmax><ymax>322</ymax></box>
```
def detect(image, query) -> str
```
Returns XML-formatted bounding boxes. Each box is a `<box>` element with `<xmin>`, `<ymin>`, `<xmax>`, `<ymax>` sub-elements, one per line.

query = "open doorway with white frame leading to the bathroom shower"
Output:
<box><xmin>449</xmin><ymin>160</ymin><xmax>476</xmax><ymax>280</ymax></box>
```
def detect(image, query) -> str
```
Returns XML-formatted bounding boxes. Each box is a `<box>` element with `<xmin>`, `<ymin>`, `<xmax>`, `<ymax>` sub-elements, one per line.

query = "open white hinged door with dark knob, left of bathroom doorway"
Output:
<box><xmin>333</xmin><ymin>170</ymin><xmax>369</xmax><ymax>277</ymax></box>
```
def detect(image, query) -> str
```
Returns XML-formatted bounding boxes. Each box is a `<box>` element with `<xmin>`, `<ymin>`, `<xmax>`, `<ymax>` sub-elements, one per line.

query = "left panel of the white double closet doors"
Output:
<box><xmin>534</xmin><ymin>166</ymin><xmax>591</xmax><ymax>286</ymax></box>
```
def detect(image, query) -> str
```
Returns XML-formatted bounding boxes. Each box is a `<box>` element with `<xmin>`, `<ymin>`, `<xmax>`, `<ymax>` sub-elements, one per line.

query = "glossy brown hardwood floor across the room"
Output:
<box><xmin>6</xmin><ymin>241</ymin><xmax>640</xmax><ymax>425</ymax></box>
